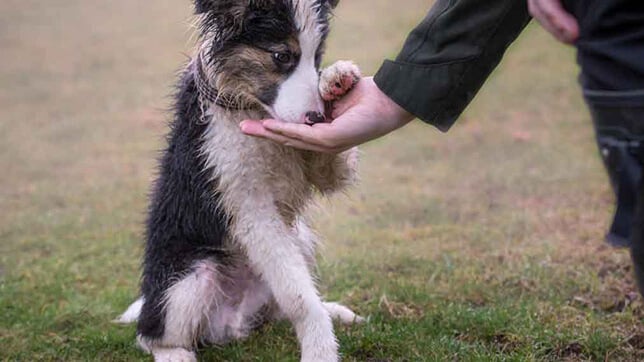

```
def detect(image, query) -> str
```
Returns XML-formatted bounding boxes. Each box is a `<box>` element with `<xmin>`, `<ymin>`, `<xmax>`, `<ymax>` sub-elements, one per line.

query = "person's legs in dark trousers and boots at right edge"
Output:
<box><xmin>562</xmin><ymin>0</ymin><xmax>644</xmax><ymax>293</ymax></box>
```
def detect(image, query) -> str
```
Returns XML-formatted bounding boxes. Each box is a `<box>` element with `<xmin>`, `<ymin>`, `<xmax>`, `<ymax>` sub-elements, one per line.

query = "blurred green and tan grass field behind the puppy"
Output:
<box><xmin>0</xmin><ymin>0</ymin><xmax>644</xmax><ymax>362</ymax></box>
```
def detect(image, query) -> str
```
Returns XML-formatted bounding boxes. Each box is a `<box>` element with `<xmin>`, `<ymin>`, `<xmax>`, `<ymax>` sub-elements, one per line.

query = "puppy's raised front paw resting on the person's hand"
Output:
<box><xmin>320</xmin><ymin>60</ymin><xmax>362</xmax><ymax>101</ymax></box>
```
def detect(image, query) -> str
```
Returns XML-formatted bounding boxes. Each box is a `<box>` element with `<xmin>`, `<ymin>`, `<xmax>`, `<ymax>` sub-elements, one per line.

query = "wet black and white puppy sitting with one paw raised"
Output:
<box><xmin>119</xmin><ymin>0</ymin><xmax>361</xmax><ymax>361</ymax></box>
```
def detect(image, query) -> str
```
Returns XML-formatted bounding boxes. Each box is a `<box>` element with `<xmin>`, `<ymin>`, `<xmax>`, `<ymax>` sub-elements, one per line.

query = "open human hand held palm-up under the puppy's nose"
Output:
<box><xmin>240</xmin><ymin>77</ymin><xmax>414</xmax><ymax>153</ymax></box>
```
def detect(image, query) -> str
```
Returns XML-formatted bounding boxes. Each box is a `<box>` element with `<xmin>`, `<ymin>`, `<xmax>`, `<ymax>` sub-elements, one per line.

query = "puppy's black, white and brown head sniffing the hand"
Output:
<box><xmin>195</xmin><ymin>0</ymin><xmax>338</xmax><ymax>123</ymax></box>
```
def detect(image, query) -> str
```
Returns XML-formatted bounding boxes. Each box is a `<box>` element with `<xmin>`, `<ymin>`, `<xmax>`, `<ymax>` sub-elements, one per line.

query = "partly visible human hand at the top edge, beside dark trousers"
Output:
<box><xmin>528</xmin><ymin>0</ymin><xmax>579</xmax><ymax>44</ymax></box>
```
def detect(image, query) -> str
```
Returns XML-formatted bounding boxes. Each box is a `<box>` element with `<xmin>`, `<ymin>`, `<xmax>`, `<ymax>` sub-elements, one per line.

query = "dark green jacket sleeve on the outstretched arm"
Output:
<box><xmin>374</xmin><ymin>0</ymin><xmax>530</xmax><ymax>131</ymax></box>
